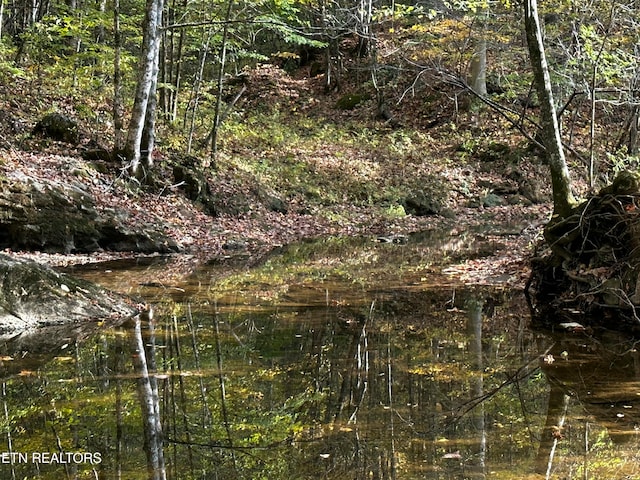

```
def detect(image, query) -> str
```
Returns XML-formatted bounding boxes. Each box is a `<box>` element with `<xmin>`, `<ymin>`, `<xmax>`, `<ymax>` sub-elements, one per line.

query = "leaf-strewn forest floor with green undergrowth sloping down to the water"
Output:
<box><xmin>0</xmin><ymin>66</ymin><xmax>550</xmax><ymax>285</ymax></box>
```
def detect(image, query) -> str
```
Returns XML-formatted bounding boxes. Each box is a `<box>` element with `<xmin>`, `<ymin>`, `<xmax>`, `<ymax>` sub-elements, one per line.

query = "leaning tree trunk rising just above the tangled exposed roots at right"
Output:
<box><xmin>524</xmin><ymin>0</ymin><xmax>575</xmax><ymax>218</ymax></box>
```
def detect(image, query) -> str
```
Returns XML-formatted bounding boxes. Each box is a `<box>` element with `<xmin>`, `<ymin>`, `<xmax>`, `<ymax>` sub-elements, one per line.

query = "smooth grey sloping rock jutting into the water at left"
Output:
<box><xmin>0</xmin><ymin>254</ymin><xmax>138</xmax><ymax>338</ymax></box>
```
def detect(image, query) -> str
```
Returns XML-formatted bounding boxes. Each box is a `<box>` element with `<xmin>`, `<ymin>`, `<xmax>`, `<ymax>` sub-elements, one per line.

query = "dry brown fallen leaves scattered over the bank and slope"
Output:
<box><xmin>0</xmin><ymin>65</ymin><xmax>549</xmax><ymax>290</ymax></box>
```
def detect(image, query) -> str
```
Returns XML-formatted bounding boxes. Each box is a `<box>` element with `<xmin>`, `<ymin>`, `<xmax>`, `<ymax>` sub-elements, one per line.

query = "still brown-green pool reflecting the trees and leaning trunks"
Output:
<box><xmin>0</xmin><ymin>232</ymin><xmax>640</xmax><ymax>480</ymax></box>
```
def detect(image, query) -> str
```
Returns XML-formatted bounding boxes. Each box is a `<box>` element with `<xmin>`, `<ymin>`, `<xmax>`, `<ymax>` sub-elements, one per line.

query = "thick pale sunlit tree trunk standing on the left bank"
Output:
<box><xmin>124</xmin><ymin>0</ymin><xmax>163</xmax><ymax>177</ymax></box>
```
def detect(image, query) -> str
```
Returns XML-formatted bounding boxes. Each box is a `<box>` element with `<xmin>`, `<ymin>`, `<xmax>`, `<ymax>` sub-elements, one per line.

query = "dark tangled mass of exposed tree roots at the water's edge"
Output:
<box><xmin>527</xmin><ymin>172</ymin><xmax>640</xmax><ymax>333</ymax></box>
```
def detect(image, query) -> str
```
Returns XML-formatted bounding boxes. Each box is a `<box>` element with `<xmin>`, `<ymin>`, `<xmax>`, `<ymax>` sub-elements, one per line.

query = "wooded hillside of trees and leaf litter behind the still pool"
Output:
<box><xmin>0</xmin><ymin>0</ymin><xmax>640</xmax><ymax>322</ymax></box>
